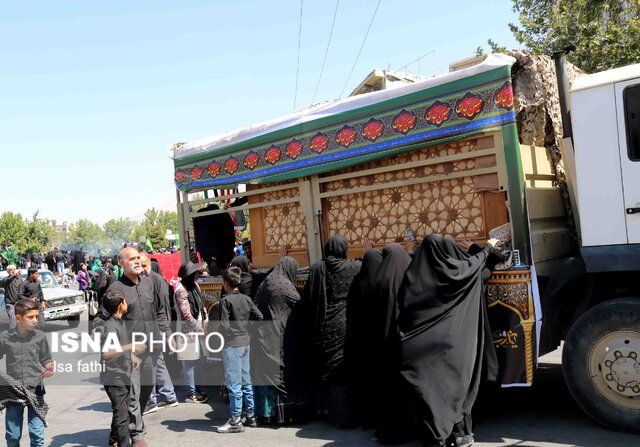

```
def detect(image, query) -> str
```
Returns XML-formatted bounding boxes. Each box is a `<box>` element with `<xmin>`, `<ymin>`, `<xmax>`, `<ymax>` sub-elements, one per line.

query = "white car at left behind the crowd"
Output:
<box><xmin>0</xmin><ymin>269</ymin><xmax>87</xmax><ymax>327</ymax></box>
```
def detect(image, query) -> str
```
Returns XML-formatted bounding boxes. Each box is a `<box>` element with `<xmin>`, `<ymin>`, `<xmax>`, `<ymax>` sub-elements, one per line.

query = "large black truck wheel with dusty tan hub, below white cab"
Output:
<box><xmin>562</xmin><ymin>298</ymin><xmax>640</xmax><ymax>432</ymax></box>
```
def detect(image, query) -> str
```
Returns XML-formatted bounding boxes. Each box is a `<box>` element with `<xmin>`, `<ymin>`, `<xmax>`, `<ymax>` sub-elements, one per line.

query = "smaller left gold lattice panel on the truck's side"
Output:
<box><xmin>262</xmin><ymin>188</ymin><xmax>307</xmax><ymax>252</ymax></box>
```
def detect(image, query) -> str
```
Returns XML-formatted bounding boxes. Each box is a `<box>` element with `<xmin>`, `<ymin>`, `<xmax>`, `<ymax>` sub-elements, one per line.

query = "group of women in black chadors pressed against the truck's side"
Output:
<box><xmin>238</xmin><ymin>234</ymin><xmax>497</xmax><ymax>446</ymax></box>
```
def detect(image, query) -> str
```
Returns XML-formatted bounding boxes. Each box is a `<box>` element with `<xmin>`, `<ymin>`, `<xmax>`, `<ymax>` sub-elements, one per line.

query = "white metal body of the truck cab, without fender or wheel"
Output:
<box><xmin>570</xmin><ymin>64</ymin><xmax>640</xmax><ymax>247</ymax></box>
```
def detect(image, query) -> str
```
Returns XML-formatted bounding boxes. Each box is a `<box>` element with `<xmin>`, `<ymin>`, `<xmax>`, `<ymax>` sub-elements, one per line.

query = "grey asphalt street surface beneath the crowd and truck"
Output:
<box><xmin>0</xmin><ymin>311</ymin><xmax>640</xmax><ymax>447</ymax></box>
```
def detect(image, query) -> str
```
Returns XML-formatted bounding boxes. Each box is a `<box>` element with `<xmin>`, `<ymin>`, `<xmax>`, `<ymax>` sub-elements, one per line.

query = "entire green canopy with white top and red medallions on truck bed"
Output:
<box><xmin>173</xmin><ymin>55</ymin><xmax>515</xmax><ymax>191</ymax></box>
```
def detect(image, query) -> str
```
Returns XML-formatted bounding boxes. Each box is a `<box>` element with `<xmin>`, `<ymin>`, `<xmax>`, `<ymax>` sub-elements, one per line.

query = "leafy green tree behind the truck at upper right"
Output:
<box><xmin>509</xmin><ymin>0</ymin><xmax>640</xmax><ymax>73</ymax></box>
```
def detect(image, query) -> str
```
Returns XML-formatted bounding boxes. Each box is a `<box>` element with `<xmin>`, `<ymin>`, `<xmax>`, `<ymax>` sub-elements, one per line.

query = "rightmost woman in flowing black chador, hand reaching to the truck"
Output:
<box><xmin>398</xmin><ymin>234</ymin><xmax>498</xmax><ymax>446</ymax></box>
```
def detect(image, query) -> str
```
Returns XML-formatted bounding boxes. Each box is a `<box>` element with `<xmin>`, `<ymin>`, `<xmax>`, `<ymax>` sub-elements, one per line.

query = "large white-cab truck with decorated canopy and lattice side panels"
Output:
<box><xmin>172</xmin><ymin>52</ymin><xmax>640</xmax><ymax>430</ymax></box>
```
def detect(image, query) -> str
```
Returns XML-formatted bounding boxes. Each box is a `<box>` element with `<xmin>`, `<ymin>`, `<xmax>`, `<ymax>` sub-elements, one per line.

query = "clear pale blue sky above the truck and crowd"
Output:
<box><xmin>0</xmin><ymin>0</ymin><xmax>518</xmax><ymax>224</ymax></box>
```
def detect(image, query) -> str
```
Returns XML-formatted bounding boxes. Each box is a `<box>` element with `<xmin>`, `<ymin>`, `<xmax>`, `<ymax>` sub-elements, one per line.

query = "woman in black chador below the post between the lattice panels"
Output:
<box><xmin>303</xmin><ymin>235</ymin><xmax>361</xmax><ymax>424</ymax></box>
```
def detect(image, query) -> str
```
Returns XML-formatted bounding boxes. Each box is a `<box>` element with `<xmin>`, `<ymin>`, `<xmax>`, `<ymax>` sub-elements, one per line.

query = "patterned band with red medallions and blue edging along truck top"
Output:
<box><xmin>175</xmin><ymin>77</ymin><xmax>516</xmax><ymax>191</ymax></box>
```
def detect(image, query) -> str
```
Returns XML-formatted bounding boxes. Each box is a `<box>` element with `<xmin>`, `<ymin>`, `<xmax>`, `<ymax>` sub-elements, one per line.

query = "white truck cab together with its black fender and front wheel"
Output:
<box><xmin>542</xmin><ymin>53</ymin><xmax>640</xmax><ymax>431</ymax></box>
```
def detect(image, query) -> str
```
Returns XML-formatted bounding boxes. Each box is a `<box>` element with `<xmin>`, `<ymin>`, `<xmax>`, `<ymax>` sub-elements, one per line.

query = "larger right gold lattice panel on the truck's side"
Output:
<box><xmin>323</xmin><ymin>141</ymin><xmax>486</xmax><ymax>245</ymax></box>
